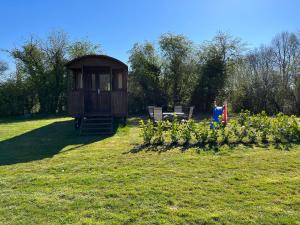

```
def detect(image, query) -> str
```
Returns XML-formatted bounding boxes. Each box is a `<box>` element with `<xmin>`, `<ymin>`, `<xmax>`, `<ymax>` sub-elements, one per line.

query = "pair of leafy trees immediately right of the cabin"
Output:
<box><xmin>128</xmin><ymin>33</ymin><xmax>197</xmax><ymax>113</ymax></box>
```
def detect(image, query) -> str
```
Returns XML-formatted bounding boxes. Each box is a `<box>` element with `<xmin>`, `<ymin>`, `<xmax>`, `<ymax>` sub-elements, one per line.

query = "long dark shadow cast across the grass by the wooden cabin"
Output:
<box><xmin>0</xmin><ymin>120</ymin><xmax>108</xmax><ymax>166</ymax></box>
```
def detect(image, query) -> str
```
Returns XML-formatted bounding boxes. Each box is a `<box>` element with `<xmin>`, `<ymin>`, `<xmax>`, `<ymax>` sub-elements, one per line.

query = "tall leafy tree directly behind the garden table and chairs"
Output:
<box><xmin>159</xmin><ymin>33</ymin><xmax>196</xmax><ymax>106</ymax></box>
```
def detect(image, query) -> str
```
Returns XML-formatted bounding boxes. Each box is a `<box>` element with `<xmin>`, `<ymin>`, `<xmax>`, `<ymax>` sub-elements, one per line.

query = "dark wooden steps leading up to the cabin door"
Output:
<box><xmin>80</xmin><ymin>115</ymin><xmax>114</xmax><ymax>135</ymax></box>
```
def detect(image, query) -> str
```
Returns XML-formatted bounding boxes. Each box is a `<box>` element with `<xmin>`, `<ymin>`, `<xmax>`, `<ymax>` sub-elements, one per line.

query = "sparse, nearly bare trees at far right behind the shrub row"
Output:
<box><xmin>229</xmin><ymin>32</ymin><xmax>300</xmax><ymax>114</ymax></box>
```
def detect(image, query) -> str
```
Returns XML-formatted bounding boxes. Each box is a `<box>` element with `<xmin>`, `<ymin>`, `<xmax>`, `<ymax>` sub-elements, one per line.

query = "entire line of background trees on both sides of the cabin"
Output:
<box><xmin>0</xmin><ymin>29</ymin><xmax>300</xmax><ymax>116</ymax></box>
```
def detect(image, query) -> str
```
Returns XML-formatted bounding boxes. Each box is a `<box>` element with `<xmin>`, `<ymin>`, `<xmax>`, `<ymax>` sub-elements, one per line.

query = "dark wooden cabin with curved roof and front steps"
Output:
<box><xmin>66</xmin><ymin>55</ymin><xmax>128</xmax><ymax>133</ymax></box>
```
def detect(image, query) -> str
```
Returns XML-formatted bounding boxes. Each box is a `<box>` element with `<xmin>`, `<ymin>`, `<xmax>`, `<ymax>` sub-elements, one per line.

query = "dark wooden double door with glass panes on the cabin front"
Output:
<box><xmin>84</xmin><ymin>71</ymin><xmax>111</xmax><ymax>114</ymax></box>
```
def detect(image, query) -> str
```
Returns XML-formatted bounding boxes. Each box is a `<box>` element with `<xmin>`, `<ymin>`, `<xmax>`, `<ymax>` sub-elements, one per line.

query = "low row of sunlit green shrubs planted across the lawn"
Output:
<box><xmin>141</xmin><ymin>111</ymin><xmax>300</xmax><ymax>147</ymax></box>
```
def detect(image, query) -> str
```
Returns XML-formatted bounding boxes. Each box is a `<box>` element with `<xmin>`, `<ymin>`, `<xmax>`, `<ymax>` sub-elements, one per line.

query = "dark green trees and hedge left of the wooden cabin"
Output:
<box><xmin>0</xmin><ymin>32</ymin><xmax>101</xmax><ymax>116</ymax></box>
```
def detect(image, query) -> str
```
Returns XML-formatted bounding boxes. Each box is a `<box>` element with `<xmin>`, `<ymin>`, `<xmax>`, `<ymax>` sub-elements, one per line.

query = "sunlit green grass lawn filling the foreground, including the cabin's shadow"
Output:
<box><xmin>0</xmin><ymin>118</ymin><xmax>300</xmax><ymax>224</ymax></box>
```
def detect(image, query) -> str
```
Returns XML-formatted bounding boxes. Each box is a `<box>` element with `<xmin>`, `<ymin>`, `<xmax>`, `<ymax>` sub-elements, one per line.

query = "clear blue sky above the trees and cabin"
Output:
<box><xmin>0</xmin><ymin>0</ymin><xmax>300</xmax><ymax>70</ymax></box>
